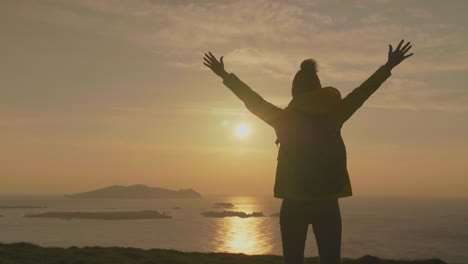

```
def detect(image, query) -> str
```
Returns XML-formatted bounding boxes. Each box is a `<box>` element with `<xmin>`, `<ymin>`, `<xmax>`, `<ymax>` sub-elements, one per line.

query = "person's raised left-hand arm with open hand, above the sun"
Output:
<box><xmin>203</xmin><ymin>52</ymin><xmax>284</xmax><ymax>127</ymax></box>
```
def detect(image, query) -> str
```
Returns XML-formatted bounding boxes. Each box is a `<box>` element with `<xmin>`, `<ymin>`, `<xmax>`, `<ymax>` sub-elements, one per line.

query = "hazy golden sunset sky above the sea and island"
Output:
<box><xmin>0</xmin><ymin>0</ymin><xmax>468</xmax><ymax>196</ymax></box>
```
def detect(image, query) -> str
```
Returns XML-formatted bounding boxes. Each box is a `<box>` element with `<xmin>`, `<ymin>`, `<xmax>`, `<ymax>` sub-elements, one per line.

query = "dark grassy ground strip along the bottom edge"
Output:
<box><xmin>0</xmin><ymin>242</ymin><xmax>447</xmax><ymax>264</ymax></box>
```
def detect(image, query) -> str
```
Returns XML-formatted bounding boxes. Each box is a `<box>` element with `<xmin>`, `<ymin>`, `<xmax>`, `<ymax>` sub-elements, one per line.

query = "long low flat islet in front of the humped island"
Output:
<box><xmin>24</xmin><ymin>210</ymin><xmax>172</xmax><ymax>220</ymax></box>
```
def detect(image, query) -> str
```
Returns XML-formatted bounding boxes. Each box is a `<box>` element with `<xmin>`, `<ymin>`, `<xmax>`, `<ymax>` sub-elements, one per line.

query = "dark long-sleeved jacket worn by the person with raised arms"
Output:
<box><xmin>224</xmin><ymin>66</ymin><xmax>391</xmax><ymax>200</ymax></box>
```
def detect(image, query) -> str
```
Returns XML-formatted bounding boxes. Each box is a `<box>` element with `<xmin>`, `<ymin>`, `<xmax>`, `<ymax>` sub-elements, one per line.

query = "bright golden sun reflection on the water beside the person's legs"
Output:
<box><xmin>215</xmin><ymin>197</ymin><xmax>272</xmax><ymax>254</ymax></box>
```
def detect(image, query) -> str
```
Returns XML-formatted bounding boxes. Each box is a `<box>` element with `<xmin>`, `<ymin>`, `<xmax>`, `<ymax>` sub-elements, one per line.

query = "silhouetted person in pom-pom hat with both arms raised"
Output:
<box><xmin>203</xmin><ymin>40</ymin><xmax>413</xmax><ymax>264</ymax></box>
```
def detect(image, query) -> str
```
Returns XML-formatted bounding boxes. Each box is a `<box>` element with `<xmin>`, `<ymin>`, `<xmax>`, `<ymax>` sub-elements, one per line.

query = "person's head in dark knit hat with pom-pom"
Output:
<box><xmin>292</xmin><ymin>59</ymin><xmax>322</xmax><ymax>98</ymax></box>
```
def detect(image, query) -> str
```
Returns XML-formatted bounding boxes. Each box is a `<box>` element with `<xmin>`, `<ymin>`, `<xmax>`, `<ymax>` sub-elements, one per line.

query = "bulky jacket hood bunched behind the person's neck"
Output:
<box><xmin>286</xmin><ymin>87</ymin><xmax>341</xmax><ymax>114</ymax></box>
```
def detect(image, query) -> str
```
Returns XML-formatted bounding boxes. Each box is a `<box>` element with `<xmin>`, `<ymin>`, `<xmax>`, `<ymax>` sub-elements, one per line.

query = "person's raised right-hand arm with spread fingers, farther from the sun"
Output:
<box><xmin>337</xmin><ymin>40</ymin><xmax>413</xmax><ymax>123</ymax></box>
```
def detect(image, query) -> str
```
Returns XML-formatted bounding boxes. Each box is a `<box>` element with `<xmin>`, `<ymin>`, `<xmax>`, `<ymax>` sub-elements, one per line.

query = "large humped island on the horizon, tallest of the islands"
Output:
<box><xmin>65</xmin><ymin>184</ymin><xmax>201</xmax><ymax>199</ymax></box>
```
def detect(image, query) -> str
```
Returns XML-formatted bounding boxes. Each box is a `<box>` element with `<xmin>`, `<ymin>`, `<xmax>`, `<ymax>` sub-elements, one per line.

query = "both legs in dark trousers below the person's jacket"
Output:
<box><xmin>280</xmin><ymin>199</ymin><xmax>341</xmax><ymax>264</ymax></box>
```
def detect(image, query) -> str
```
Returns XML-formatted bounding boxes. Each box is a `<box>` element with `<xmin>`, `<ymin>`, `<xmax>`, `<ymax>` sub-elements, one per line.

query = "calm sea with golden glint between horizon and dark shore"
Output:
<box><xmin>0</xmin><ymin>196</ymin><xmax>468</xmax><ymax>264</ymax></box>
